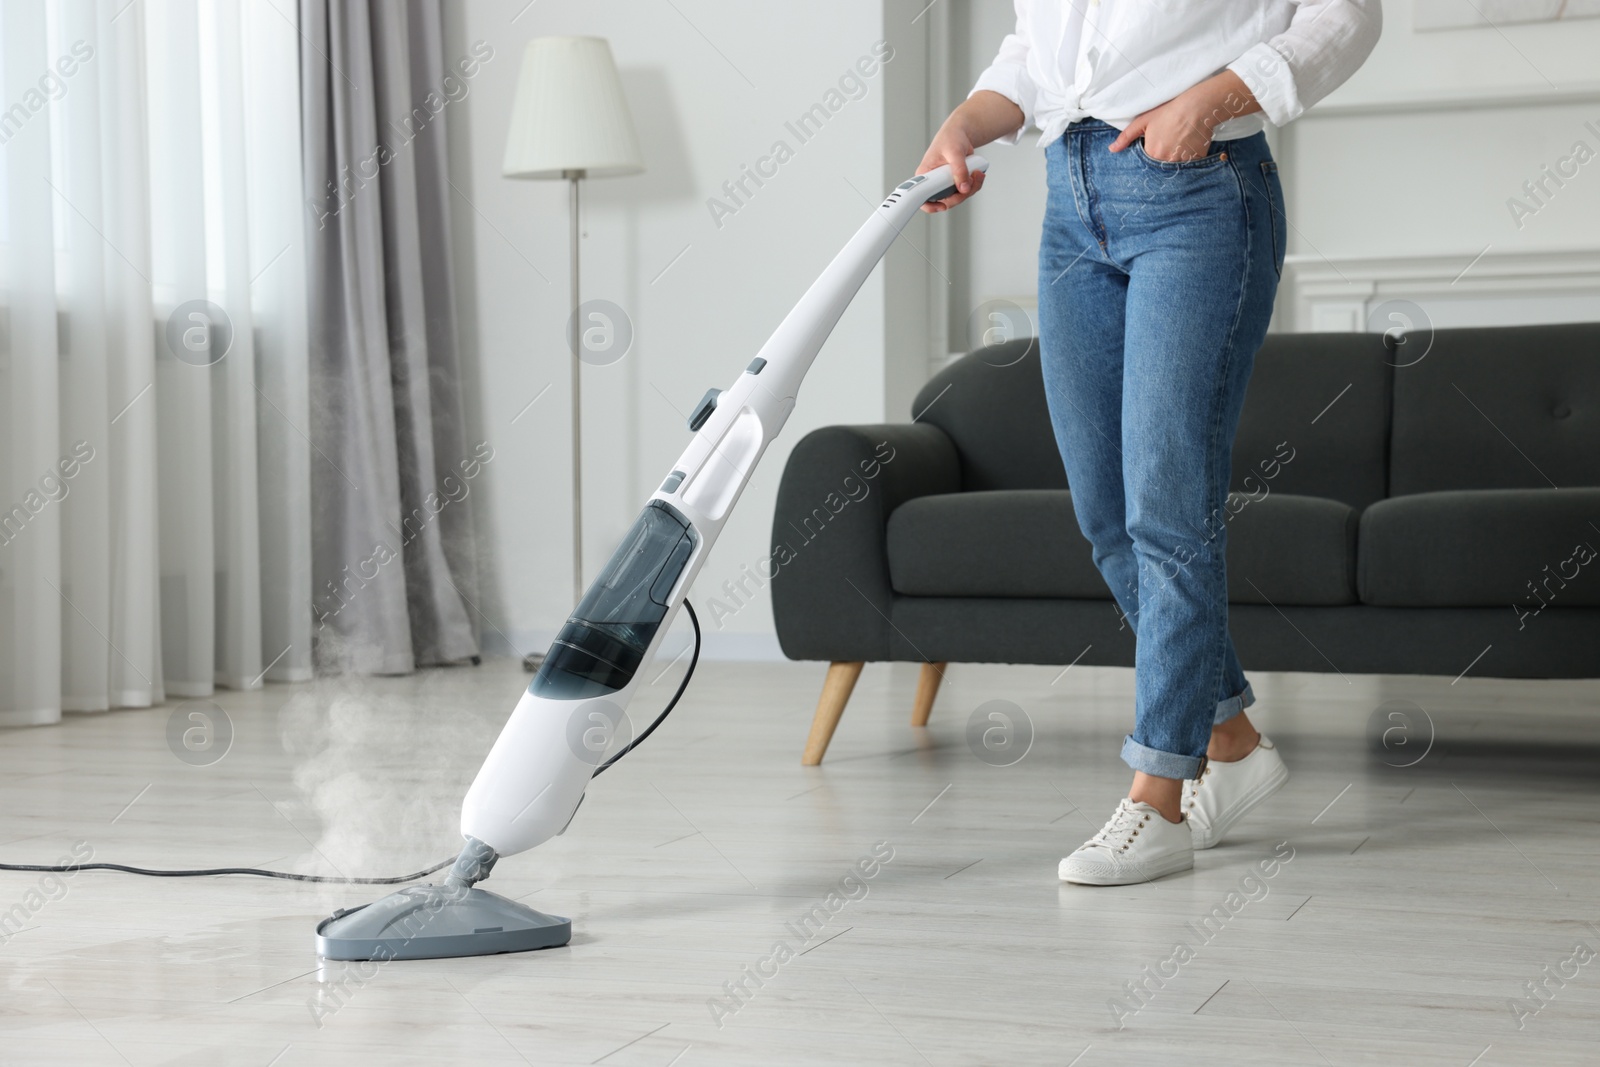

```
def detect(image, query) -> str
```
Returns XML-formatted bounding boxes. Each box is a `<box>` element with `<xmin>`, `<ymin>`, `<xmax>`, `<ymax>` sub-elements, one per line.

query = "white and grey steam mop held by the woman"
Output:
<box><xmin>317</xmin><ymin>155</ymin><xmax>989</xmax><ymax>960</ymax></box>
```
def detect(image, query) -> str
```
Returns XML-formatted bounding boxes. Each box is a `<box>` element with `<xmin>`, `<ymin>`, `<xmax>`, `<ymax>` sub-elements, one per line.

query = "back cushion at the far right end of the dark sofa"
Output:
<box><xmin>1389</xmin><ymin>323</ymin><xmax>1600</xmax><ymax>495</ymax></box>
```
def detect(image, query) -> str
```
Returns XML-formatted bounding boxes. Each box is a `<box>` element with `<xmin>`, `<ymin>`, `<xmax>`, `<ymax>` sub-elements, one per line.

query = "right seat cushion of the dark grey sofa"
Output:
<box><xmin>1358</xmin><ymin>488</ymin><xmax>1600</xmax><ymax>608</ymax></box>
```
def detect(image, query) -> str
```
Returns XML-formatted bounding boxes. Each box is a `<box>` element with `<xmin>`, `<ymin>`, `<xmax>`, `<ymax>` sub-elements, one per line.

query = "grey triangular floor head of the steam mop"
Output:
<box><xmin>317</xmin><ymin>885</ymin><xmax>573</xmax><ymax>961</ymax></box>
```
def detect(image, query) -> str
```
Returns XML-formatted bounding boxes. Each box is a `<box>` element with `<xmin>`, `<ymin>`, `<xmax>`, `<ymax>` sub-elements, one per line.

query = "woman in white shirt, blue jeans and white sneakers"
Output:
<box><xmin>918</xmin><ymin>0</ymin><xmax>1381</xmax><ymax>885</ymax></box>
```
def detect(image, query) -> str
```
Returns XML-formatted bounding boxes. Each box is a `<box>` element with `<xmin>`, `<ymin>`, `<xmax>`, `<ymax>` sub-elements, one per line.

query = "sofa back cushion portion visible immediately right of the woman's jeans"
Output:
<box><xmin>1229</xmin><ymin>333</ymin><xmax>1394</xmax><ymax>507</ymax></box>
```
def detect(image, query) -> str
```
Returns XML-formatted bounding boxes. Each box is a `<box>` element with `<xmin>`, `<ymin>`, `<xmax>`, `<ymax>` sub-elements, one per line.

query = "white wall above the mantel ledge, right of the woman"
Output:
<box><xmin>1285</xmin><ymin>0</ymin><xmax>1600</xmax><ymax>256</ymax></box>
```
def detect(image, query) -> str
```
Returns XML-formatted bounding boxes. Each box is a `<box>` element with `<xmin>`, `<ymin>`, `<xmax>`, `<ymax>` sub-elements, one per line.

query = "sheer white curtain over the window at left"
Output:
<box><xmin>0</xmin><ymin>0</ymin><xmax>312</xmax><ymax>725</ymax></box>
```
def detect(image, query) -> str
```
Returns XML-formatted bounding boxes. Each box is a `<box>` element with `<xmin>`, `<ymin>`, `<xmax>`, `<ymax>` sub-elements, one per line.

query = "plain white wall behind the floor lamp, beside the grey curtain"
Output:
<box><xmin>446</xmin><ymin>0</ymin><xmax>926</xmax><ymax>657</ymax></box>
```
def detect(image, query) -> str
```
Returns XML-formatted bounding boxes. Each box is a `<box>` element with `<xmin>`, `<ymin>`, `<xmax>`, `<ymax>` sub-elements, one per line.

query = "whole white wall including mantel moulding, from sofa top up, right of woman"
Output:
<box><xmin>1278</xmin><ymin>0</ymin><xmax>1600</xmax><ymax>330</ymax></box>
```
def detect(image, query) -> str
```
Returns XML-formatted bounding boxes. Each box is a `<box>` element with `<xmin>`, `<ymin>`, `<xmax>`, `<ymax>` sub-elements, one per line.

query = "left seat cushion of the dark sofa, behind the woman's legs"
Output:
<box><xmin>888</xmin><ymin>490</ymin><xmax>1357</xmax><ymax>605</ymax></box>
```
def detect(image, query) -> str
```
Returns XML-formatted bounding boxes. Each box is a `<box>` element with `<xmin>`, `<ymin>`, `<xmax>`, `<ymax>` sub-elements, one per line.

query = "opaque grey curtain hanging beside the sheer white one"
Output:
<box><xmin>301</xmin><ymin>0</ymin><xmax>483</xmax><ymax>673</ymax></box>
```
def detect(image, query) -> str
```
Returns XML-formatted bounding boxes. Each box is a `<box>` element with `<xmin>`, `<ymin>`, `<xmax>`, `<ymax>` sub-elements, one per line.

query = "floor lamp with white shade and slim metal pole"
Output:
<box><xmin>501</xmin><ymin>37</ymin><xmax>645</xmax><ymax>665</ymax></box>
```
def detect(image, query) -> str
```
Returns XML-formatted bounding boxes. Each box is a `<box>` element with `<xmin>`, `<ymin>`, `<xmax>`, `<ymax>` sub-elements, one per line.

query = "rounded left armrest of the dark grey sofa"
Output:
<box><xmin>770</xmin><ymin>424</ymin><xmax>962</xmax><ymax>661</ymax></box>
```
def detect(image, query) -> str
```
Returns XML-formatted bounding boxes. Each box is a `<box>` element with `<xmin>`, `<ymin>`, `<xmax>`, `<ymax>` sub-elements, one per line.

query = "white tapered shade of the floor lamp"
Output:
<box><xmin>501</xmin><ymin>37</ymin><xmax>645</xmax><ymax>178</ymax></box>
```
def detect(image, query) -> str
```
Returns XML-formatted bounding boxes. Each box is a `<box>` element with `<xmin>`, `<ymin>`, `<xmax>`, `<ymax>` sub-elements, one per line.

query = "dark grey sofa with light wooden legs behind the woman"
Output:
<box><xmin>773</xmin><ymin>323</ymin><xmax>1600</xmax><ymax>763</ymax></box>
